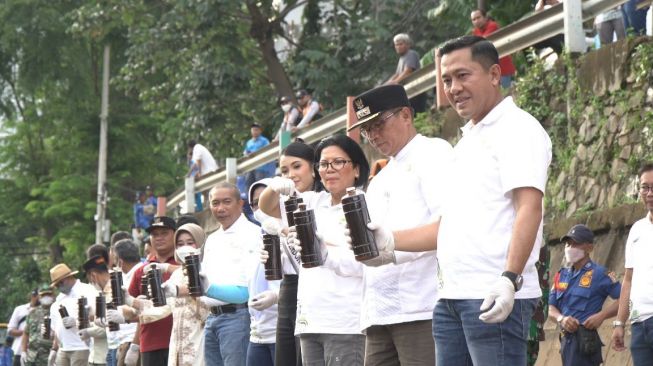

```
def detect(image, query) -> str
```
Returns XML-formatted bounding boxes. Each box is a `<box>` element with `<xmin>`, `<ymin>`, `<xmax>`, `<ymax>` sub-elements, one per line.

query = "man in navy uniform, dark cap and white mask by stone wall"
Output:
<box><xmin>549</xmin><ymin>224</ymin><xmax>621</xmax><ymax>366</ymax></box>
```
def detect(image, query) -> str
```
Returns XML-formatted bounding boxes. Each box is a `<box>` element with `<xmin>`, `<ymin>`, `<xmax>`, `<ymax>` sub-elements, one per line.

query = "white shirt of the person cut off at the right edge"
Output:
<box><xmin>626</xmin><ymin>213</ymin><xmax>653</xmax><ymax>323</ymax></box>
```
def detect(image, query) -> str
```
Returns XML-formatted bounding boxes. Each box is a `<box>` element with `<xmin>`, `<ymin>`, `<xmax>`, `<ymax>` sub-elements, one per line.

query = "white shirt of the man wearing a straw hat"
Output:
<box><xmin>50</xmin><ymin>280</ymin><xmax>98</xmax><ymax>351</ymax></box>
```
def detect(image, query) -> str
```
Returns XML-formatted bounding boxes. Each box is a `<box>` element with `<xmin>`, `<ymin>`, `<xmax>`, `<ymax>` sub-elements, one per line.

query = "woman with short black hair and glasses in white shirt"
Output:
<box><xmin>272</xmin><ymin>135</ymin><xmax>369</xmax><ymax>366</ymax></box>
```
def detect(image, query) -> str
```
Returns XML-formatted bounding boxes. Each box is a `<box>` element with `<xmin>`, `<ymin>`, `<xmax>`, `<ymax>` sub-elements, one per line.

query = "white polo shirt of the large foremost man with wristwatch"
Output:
<box><xmin>438</xmin><ymin>97</ymin><xmax>551</xmax><ymax>299</ymax></box>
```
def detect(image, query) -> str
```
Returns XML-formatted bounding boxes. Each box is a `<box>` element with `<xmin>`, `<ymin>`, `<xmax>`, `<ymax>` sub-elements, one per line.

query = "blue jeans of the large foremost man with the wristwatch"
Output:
<box><xmin>433</xmin><ymin>299</ymin><xmax>538</xmax><ymax>366</ymax></box>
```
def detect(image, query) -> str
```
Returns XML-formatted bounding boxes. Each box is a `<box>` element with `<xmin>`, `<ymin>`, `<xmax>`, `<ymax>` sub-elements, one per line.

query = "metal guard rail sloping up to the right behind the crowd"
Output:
<box><xmin>166</xmin><ymin>0</ymin><xmax>627</xmax><ymax>210</ymax></box>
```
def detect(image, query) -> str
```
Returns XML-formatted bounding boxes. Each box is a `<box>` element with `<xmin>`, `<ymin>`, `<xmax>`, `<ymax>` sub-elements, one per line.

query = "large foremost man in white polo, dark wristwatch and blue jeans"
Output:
<box><xmin>366</xmin><ymin>36</ymin><xmax>551</xmax><ymax>366</ymax></box>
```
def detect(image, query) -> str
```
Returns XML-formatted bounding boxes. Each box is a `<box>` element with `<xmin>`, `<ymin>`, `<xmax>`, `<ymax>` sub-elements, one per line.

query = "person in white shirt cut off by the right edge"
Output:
<box><xmin>612</xmin><ymin>162</ymin><xmax>653</xmax><ymax>365</ymax></box>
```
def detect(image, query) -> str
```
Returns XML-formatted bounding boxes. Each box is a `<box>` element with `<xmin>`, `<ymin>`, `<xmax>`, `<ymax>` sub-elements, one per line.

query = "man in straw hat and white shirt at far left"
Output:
<box><xmin>48</xmin><ymin>263</ymin><xmax>97</xmax><ymax>366</ymax></box>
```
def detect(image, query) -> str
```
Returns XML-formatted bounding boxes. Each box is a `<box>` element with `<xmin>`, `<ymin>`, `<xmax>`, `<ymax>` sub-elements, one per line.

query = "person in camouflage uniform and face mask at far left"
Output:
<box><xmin>22</xmin><ymin>286</ymin><xmax>54</xmax><ymax>366</ymax></box>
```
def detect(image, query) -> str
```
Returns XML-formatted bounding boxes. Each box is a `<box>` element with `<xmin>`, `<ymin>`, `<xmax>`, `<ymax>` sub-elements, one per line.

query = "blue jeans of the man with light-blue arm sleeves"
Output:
<box><xmin>204</xmin><ymin>308</ymin><xmax>249</xmax><ymax>366</ymax></box>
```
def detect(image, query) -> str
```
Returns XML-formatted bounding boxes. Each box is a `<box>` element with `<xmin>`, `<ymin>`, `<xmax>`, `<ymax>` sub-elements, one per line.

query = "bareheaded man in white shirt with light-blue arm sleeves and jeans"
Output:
<box><xmin>202</xmin><ymin>183</ymin><xmax>262</xmax><ymax>366</ymax></box>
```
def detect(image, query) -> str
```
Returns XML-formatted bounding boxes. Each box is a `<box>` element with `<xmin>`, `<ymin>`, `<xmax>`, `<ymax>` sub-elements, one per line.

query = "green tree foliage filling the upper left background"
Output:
<box><xmin>0</xmin><ymin>0</ymin><xmax>532</xmax><ymax>318</ymax></box>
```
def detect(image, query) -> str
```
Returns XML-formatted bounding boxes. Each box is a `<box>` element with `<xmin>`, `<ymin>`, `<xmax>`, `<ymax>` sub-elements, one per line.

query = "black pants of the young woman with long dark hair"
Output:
<box><xmin>274</xmin><ymin>275</ymin><xmax>302</xmax><ymax>366</ymax></box>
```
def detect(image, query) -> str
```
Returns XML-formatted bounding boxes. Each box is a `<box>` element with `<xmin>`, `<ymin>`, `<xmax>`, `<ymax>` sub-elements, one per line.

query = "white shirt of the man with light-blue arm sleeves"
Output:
<box><xmin>202</xmin><ymin>214</ymin><xmax>263</xmax><ymax>306</ymax></box>
